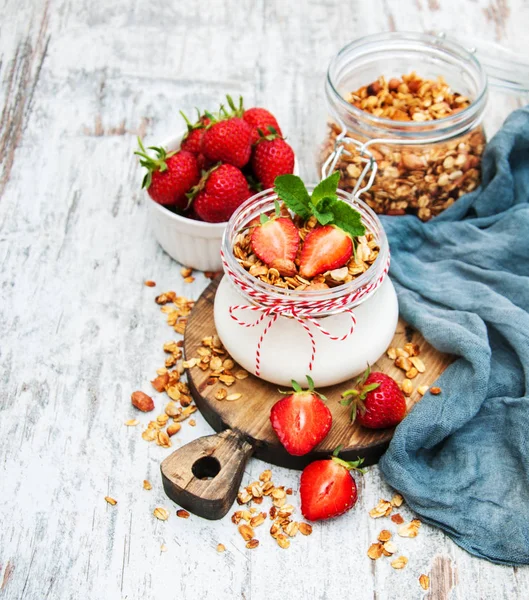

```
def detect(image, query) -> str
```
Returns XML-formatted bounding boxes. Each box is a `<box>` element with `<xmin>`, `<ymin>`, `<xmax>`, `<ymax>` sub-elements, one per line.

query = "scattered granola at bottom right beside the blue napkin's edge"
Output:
<box><xmin>367</xmin><ymin>494</ymin><xmax>430</xmax><ymax>590</ymax></box>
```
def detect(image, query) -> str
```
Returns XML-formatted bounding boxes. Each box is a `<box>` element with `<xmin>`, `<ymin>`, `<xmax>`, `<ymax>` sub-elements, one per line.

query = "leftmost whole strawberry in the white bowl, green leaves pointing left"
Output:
<box><xmin>134</xmin><ymin>138</ymin><xmax>200</xmax><ymax>210</ymax></box>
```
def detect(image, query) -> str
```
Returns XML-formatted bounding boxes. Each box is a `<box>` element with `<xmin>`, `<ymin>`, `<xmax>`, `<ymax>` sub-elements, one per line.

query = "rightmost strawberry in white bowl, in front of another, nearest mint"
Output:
<box><xmin>252</xmin><ymin>134</ymin><xmax>294</xmax><ymax>190</ymax></box>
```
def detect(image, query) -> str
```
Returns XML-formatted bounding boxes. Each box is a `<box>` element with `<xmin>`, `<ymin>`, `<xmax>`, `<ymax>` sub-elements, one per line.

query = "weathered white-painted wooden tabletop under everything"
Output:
<box><xmin>0</xmin><ymin>0</ymin><xmax>529</xmax><ymax>600</ymax></box>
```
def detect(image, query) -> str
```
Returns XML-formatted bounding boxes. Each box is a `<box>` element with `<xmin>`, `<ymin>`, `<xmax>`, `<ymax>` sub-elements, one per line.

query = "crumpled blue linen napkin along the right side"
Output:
<box><xmin>380</xmin><ymin>107</ymin><xmax>529</xmax><ymax>565</ymax></box>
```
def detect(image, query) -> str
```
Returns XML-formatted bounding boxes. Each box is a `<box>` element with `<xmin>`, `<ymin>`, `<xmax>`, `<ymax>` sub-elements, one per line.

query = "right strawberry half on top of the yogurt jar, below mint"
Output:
<box><xmin>299</xmin><ymin>225</ymin><xmax>353</xmax><ymax>279</ymax></box>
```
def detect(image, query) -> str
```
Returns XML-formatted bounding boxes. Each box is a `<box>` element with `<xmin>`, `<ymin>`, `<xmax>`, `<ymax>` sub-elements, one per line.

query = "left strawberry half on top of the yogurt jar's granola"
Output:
<box><xmin>251</xmin><ymin>216</ymin><xmax>299</xmax><ymax>265</ymax></box>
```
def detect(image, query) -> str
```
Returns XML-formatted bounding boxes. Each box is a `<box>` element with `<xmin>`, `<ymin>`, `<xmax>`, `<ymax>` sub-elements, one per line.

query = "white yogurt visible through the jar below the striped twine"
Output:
<box><xmin>215</xmin><ymin>275</ymin><xmax>399</xmax><ymax>387</ymax></box>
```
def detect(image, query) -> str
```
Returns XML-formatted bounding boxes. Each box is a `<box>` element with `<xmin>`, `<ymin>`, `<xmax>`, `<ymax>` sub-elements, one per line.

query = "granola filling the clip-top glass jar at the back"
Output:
<box><xmin>322</xmin><ymin>73</ymin><xmax>485</xmax><ymax>221</ymax></box>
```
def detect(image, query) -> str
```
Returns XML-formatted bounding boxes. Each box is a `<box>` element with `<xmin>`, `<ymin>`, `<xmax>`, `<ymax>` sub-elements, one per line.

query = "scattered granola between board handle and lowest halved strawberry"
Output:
<box><xmin>231</xmin><ymin>469</ymin><xmax>312</xmax><ymax>549</ymax></box>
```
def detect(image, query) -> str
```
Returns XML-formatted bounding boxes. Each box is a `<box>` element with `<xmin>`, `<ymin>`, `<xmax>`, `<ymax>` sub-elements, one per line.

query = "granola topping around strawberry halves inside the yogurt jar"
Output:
<box><xmin>233</xmin><ymin>216</ymin><xmax>380</xmax><ymax>291</ymax></box>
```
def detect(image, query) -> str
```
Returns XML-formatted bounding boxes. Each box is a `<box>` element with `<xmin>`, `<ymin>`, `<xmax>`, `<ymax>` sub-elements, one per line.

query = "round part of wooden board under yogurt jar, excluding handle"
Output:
<box><xmin>184</xmin><ymin>278</ymin><xmax>453</xmax><ymax>469</ymax></box>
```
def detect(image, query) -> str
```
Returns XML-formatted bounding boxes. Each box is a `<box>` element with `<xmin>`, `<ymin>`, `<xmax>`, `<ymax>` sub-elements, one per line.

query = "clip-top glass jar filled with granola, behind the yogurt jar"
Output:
<box><xmin>319</xmin><ymin>33</ymin><xmax>487</xmax><ymax>221</ymax></box>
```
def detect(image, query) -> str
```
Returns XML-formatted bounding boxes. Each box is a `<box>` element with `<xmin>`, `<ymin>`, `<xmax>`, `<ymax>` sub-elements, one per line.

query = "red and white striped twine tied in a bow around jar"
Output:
<box><xmin>221</xmin><ymin>250</ymin><xmax>390</xmax><ymax>377</ymax></box>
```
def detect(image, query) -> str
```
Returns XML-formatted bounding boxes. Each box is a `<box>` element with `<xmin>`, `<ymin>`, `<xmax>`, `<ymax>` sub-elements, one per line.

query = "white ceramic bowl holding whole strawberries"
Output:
<box><xmin>146</xmin><ymin>131</ymin><xmax>298</xmax><ymax>271</ymax></box>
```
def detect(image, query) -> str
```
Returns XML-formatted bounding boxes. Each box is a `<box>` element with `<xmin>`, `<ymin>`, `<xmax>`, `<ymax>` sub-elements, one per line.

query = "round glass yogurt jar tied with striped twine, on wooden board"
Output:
<box><xmin>214</xmin><ymin>187</ymin><xmax>398</xmax><ymax>387</ymax></box>
